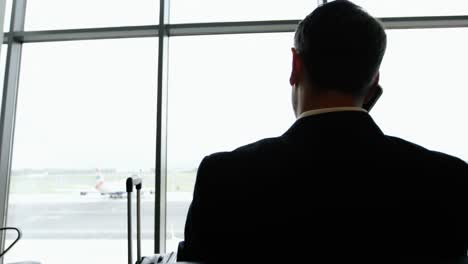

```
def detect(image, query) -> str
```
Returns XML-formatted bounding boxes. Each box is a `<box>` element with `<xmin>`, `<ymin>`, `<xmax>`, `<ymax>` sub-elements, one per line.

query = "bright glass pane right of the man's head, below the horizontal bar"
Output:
<box><xmin>372</xmin><ymin>28</ymin><xmax>468</xmax><ymax>161</ymax></box>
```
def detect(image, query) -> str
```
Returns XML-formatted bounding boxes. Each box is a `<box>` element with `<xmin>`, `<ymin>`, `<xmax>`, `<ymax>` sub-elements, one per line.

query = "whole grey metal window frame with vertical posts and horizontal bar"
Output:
<box><xmin>0</xmin><ymin>0</ymin><xmax>468</xmax><ymax>264</ymax></box>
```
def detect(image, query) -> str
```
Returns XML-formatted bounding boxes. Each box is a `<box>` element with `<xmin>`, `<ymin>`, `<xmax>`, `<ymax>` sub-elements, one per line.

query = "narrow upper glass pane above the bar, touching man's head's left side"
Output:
<box><xmin>170</xmin><ymin>0</ymin><xmax>317</xmax><ymax>23</ymax></box>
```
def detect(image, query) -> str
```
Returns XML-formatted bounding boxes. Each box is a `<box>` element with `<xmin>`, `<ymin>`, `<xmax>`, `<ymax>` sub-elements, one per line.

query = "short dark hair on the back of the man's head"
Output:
<box><xmin>294</xmin><ymin>0</ymin><xmax>387</xmax><ymax>95</ymax></box>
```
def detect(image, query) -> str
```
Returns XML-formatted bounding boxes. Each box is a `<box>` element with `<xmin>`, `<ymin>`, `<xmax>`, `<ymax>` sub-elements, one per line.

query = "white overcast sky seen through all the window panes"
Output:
<box><xmin>1</xmin><ymin>0</ymin><xmax>468</xmax><ymax>170</ymax></box>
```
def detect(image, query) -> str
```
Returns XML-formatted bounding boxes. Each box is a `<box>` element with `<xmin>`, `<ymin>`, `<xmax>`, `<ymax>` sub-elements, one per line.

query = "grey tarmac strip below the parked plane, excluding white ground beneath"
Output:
<box><xmin>8</xmin><ymin>193</ymin><xmax>191</xmax><ymax>239</ymax></box>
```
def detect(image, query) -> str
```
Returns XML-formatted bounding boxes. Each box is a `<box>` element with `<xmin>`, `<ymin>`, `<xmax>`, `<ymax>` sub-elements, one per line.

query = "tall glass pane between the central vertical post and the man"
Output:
<box><xmin>167</xmin><ymin>33</ymin><xmax>295</xmax><ymax>251</ymax></box>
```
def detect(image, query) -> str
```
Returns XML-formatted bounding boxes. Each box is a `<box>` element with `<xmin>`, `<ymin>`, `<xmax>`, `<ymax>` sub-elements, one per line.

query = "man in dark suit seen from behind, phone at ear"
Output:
<box><xmin>178</xmin><ymin>1</ymin><xmax>468</xmax><ymax>263</ymax></box>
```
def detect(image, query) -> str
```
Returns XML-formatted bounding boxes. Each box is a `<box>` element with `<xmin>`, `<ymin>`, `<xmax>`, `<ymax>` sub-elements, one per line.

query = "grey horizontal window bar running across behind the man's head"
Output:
<box><xmin>3</xmin><ymin>16</ymin><xmax>468</xmax><ymax>44</ymax></box>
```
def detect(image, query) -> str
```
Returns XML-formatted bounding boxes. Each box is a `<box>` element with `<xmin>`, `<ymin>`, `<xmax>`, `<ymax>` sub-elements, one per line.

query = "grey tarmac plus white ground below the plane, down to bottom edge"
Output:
<box><xmin>5</xmin><ymin>193</ymin><xmax>192</xmax><ymax>264</ymax></box>
